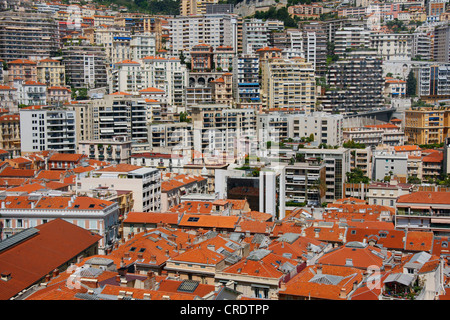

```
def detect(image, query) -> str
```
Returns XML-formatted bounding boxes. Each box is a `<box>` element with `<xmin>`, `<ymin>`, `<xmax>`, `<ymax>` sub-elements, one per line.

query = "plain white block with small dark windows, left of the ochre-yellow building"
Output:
<box><xmin>287</xmin><ymin>112</ymin><xmax>344</xmax><ymax>146</ymax></box>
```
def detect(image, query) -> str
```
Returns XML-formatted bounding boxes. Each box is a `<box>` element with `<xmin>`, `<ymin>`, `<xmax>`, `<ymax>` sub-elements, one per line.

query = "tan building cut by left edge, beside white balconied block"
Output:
<box><xmin>0</xmin><ymin>114</ymin><xmax>20</xmax><ymax>158</ymax></box>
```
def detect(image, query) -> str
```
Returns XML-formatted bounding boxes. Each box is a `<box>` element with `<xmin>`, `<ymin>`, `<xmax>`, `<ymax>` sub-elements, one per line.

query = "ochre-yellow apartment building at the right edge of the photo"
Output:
<box><xmin>405</xmin><ymin>107</ymin><xmax>450</xmax><ymax>145</ymax></box>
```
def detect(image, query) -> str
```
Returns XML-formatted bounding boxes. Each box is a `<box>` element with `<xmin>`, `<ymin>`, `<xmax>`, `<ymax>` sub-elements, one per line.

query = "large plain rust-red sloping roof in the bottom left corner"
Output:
<box><xmin>0</xmin><ymin>219</ymin><xmax>101</xmax><ymax>300</ymax></box>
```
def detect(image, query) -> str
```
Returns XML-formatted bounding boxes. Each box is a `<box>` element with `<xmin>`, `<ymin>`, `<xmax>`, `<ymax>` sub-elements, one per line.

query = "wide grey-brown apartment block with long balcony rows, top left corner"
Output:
<box><xmin>0</xmin><ymin>11</ymin><xmax>59</xmax><ymax>62</ymax></box>
